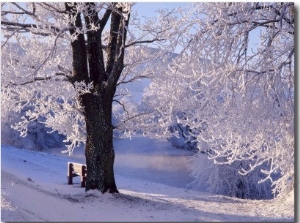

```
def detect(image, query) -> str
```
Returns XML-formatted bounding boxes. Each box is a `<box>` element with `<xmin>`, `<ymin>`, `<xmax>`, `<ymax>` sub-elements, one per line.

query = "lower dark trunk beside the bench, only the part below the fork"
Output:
<box><xmin>81</xmin><ymin>93</ymin><xmax>118</xmax><ymax>193</ymax></box>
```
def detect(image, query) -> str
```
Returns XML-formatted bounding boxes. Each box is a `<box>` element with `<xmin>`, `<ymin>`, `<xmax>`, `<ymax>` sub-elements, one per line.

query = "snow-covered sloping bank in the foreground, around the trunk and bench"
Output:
<box><xmin>1</xmin><ymin>140</ymin><xmax>293</xmax><ymax>222</ymax></box>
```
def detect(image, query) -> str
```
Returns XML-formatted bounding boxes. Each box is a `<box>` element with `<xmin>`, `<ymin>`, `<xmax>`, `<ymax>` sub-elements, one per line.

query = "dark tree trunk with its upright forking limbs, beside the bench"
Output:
<box><xmin>65</xmin><ymin>3</ymin><xmax>129</xmax><ymax>193</ymax></box>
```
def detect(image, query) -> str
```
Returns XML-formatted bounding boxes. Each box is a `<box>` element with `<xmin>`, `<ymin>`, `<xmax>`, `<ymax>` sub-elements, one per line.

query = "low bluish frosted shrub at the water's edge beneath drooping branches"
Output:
<box><xmin>189</xmin><ymin>153</ymin><xmax>280</xmax><ymax>199</ymax></box>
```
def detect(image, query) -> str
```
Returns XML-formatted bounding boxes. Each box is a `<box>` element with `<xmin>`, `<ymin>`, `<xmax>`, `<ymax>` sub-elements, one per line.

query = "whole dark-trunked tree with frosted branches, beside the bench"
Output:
<box><xmin>1</xmin><ymin>2</ymin><xmax>180</xmax><ymax>193</ymax></box>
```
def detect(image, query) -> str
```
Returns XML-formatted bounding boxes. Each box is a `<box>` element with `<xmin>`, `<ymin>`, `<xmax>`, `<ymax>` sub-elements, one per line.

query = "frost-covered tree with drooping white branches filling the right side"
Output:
<box><xmin>141</xmin><ymin>2</ymin><xmax>295</xmax><ymax>198</ymax></box>
